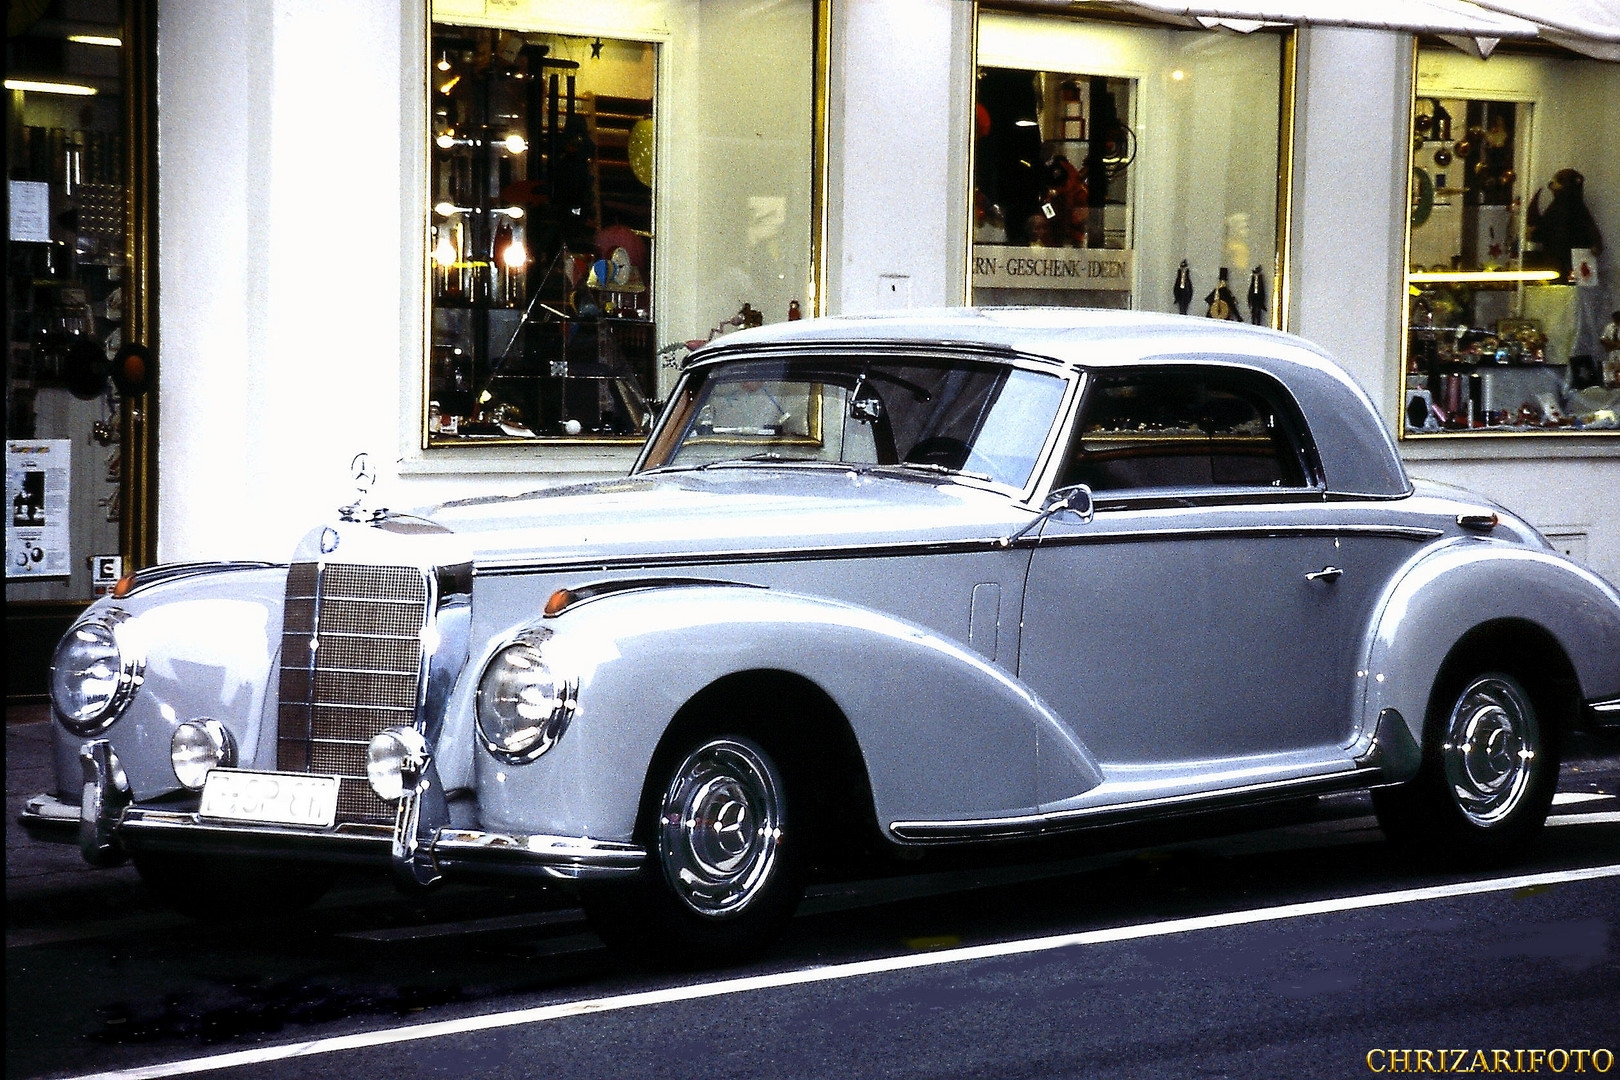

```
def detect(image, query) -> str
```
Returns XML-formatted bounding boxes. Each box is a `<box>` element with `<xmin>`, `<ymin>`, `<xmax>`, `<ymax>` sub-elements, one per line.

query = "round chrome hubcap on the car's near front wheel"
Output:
<box><xmin>658</xmin><ymin>738</ymin><xmax>782</xmax><ymax>918</ymax></box>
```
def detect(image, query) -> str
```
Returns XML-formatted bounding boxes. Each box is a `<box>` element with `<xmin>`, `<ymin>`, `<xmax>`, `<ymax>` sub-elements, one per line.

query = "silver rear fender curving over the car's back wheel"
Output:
<box><xmin>1356</xmin><ymin>539</ymin><xmax>1620</xmax><ymax>761</ymax></box>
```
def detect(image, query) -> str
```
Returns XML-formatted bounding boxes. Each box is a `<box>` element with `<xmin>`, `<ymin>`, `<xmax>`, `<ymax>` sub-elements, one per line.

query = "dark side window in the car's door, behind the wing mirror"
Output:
<box><xmin>1063</xmin><ymin>368</ymin><xmax>1309</xmax><ymax>492</ymax></box>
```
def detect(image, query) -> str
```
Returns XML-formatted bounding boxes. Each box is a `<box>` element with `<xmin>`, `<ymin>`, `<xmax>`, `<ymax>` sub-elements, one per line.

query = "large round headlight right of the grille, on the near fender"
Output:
<box><xmin>478</xmin><ymin>636</ymin><xmax>575</xmax><ymax>761</ymax></box>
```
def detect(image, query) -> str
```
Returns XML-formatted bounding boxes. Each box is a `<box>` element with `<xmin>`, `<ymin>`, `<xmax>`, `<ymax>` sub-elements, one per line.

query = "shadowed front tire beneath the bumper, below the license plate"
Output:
<box><xmin>131</xmin><ymin>852</ymin><xmax>337</xmax><ymax>920</ymax></box>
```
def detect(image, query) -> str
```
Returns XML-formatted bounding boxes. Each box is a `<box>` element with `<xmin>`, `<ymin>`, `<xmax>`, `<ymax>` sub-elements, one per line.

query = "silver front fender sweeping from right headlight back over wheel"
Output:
<box><xmin>476</xmin><ymin>585</ymin><xmax>1102</xmax><ymax>840</ymax></box>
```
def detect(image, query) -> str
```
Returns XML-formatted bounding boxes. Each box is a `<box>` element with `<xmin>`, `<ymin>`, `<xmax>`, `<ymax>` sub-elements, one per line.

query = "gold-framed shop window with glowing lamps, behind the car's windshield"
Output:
<box><xmin>423</xmin><ymin>0</ymin><xmax>816</xmax><ymax>447</ymax></box>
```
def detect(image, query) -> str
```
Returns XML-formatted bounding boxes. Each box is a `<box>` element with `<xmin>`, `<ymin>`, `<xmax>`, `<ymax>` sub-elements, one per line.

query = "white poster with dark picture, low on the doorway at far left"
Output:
<box><xmin>5</xmin><ymin>439</ymin><xmax>73</xmax><ymax>578</ymax></box>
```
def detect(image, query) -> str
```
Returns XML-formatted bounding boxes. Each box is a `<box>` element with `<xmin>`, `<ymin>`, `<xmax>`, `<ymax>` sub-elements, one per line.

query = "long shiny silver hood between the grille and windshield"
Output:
<box><xmin>423</xmin><ymin>465</ymin><xmax>1029</xmax><ymax>563</ymax></box>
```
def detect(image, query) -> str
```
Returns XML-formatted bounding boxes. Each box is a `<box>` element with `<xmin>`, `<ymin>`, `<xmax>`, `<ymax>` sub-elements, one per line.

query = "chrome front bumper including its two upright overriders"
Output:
<box><xmin>21</xmin><ymin>740</ymin><xmax>646</xmax><ymax>889</ymax></box>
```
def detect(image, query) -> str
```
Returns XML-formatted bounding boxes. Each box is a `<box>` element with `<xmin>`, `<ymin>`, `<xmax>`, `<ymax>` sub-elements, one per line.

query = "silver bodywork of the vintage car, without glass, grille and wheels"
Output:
<box><xmin>29</xmin><ymin>311</ymin><xmax>1620</xmax><ymax>882</ymax></box>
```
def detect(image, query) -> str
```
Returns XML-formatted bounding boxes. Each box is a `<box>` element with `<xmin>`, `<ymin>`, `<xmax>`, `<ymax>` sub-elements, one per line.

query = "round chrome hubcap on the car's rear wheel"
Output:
<box><xmin>1442</xmin><ymin>675</ymin><xmax>1541</xmax><ymax>826</ymax></box>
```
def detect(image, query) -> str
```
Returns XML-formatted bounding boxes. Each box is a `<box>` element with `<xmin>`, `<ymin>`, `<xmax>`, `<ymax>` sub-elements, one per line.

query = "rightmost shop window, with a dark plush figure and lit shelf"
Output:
<box><xmin>1401</xmin><ymin>47</ymin><xmax>1620</xmax><ymax>436</ymax></box>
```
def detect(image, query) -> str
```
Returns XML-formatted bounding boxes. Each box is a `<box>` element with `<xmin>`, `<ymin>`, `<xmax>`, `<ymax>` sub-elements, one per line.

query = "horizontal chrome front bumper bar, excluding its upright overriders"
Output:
<box><xmin>21</xmin><ymin>793</ymin><xmax>646</xmax><ymax>881</ymax></box>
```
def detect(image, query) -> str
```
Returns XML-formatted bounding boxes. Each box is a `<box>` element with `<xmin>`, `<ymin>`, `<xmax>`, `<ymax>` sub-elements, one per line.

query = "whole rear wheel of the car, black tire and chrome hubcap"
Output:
<box><xmin>1372</xmin><ymin>672</ymin><xmax>1558</xmax><ymax>855</ymax></box>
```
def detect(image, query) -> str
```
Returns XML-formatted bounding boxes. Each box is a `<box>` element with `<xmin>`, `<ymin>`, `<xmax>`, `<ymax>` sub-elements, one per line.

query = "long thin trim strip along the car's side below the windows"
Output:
<box><xmin>476</xmin><ymin>521</ymin><xmax>1445</xmax><ymax>576</ymax></box>
